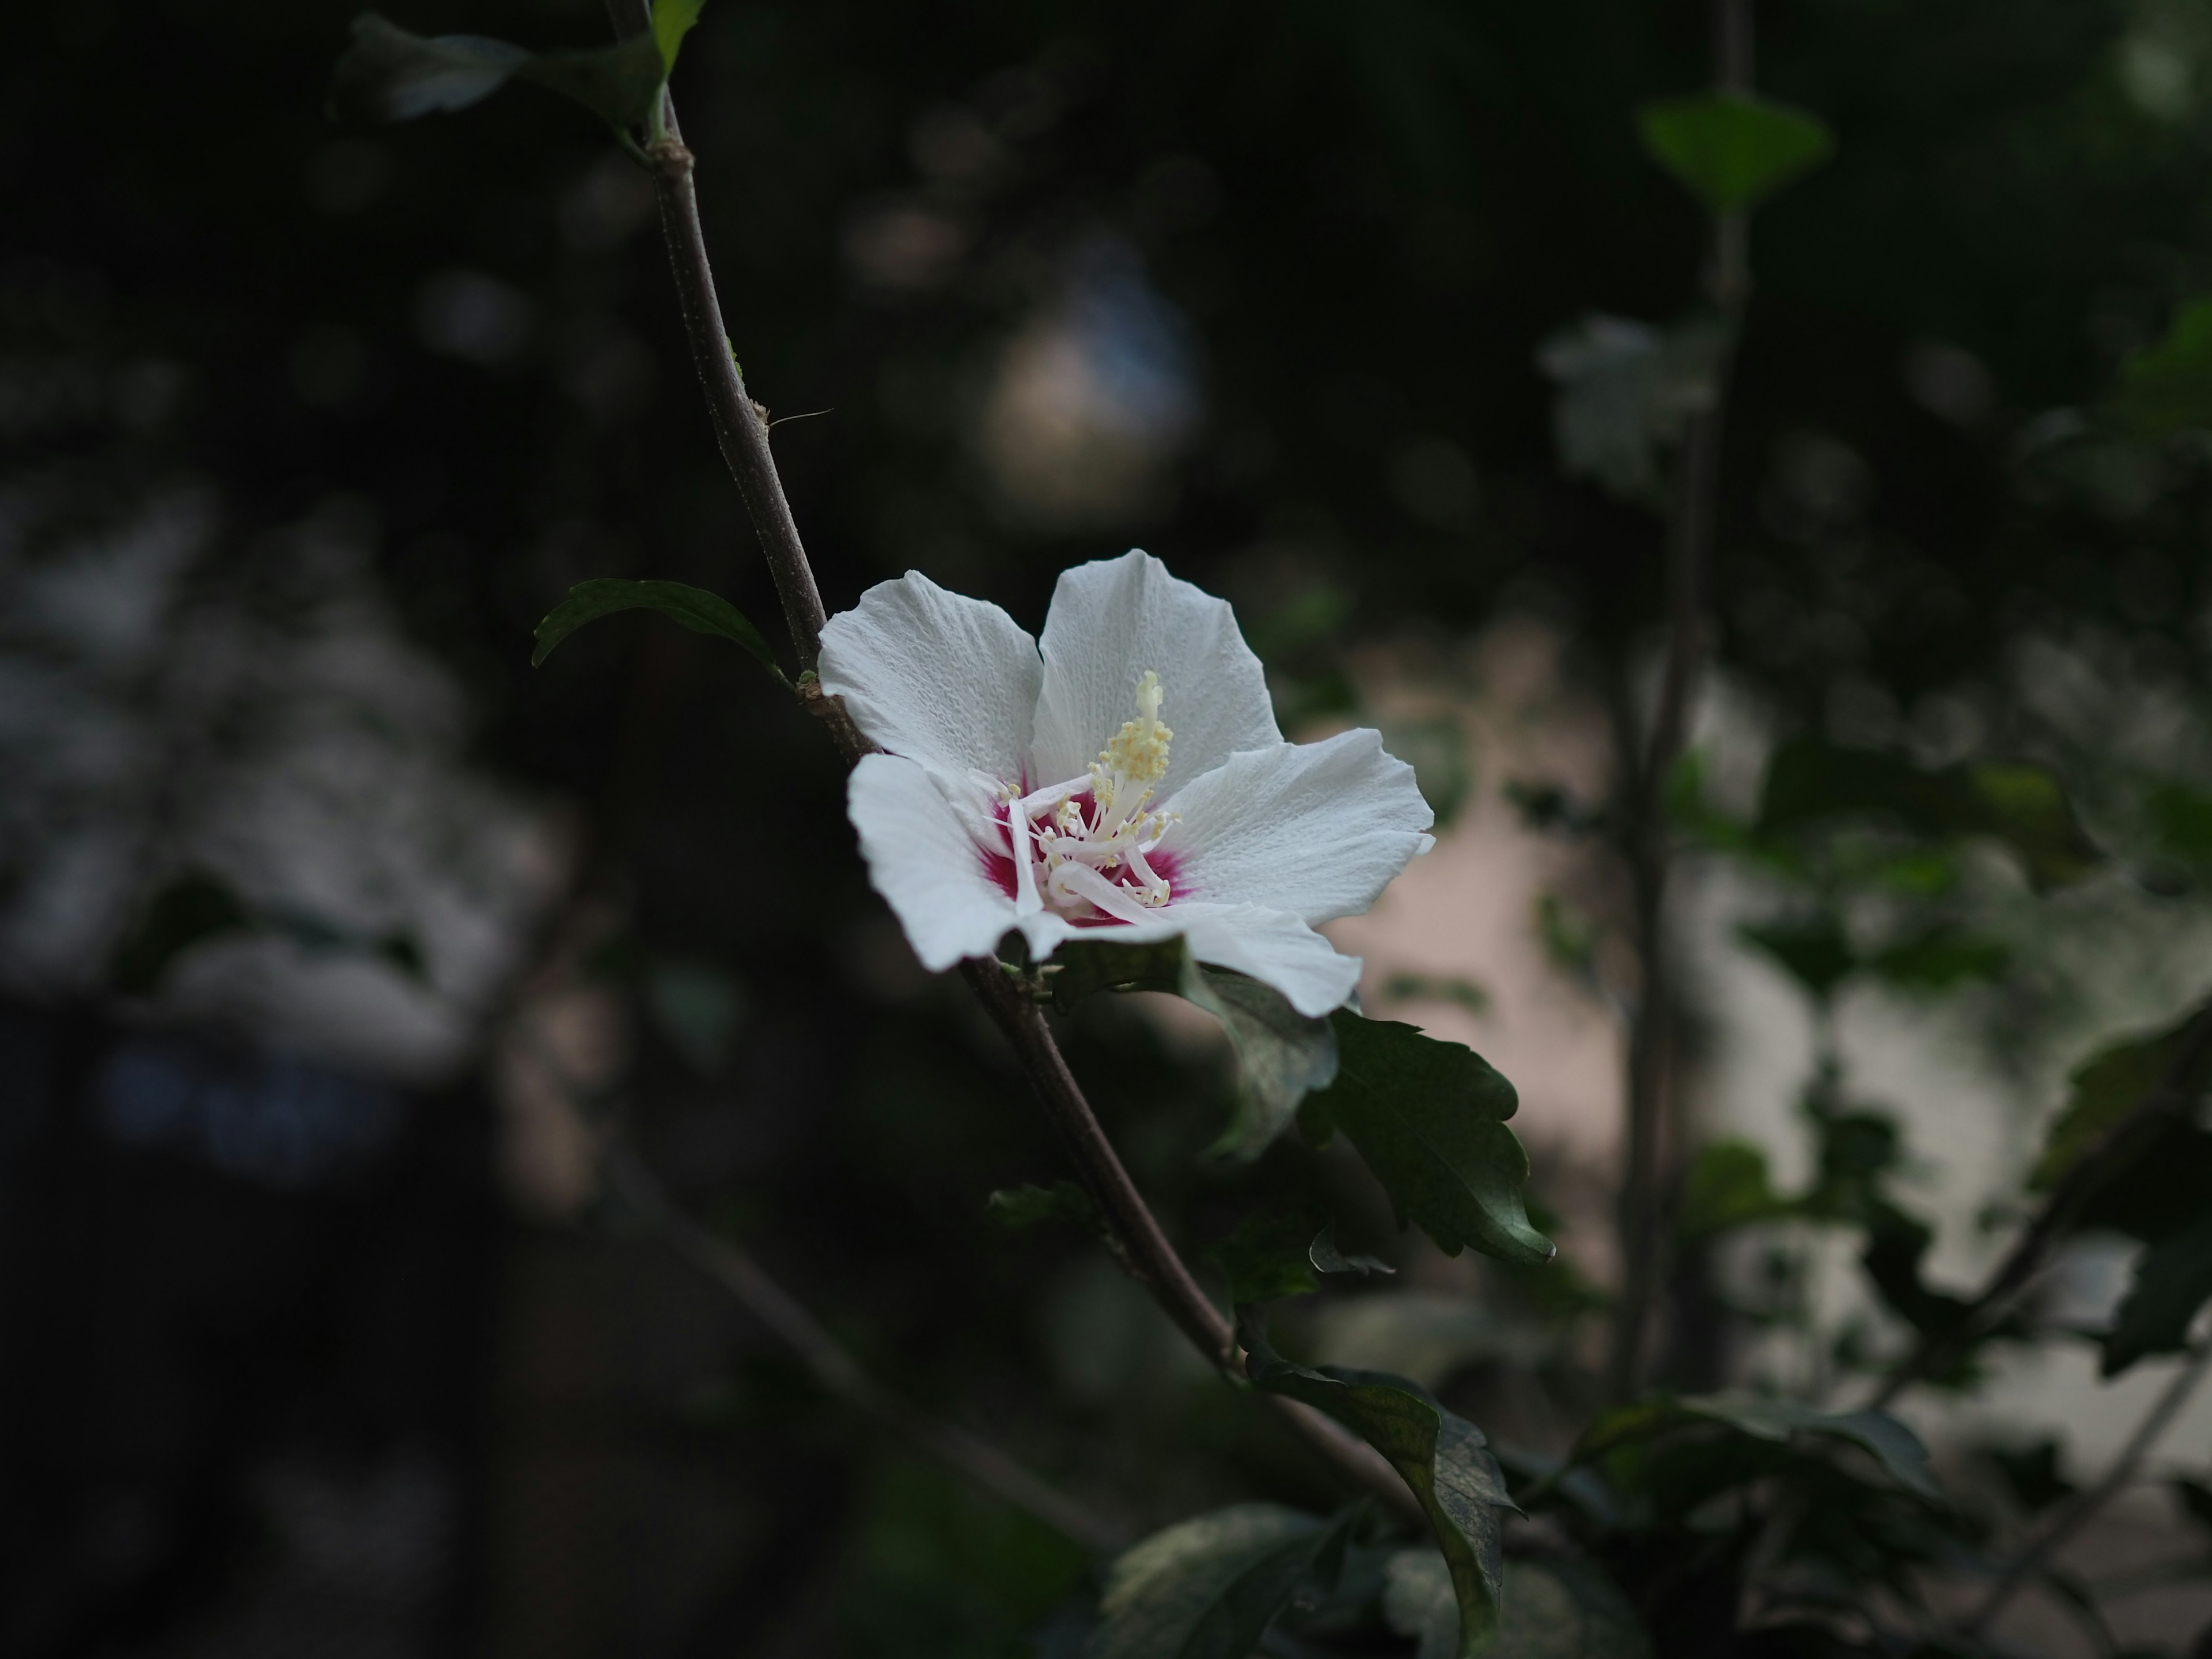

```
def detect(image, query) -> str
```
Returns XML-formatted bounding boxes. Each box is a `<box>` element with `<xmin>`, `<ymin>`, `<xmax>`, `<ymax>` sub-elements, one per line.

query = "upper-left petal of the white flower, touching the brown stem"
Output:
<box><xmin>819</xmin><ymin>571</ymin><xmax>1044</xmax><ymax>783</ymax></box>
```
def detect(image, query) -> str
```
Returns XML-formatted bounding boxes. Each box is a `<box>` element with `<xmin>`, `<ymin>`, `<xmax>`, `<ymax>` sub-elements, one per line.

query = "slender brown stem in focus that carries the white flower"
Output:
<box><xmin>588</xmin><ymin>0</ymin><xmax>1420</xmax><ymax>1520</ymax></box>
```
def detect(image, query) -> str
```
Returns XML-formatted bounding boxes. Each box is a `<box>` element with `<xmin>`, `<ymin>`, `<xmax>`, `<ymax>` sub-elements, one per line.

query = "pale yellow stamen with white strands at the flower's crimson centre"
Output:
<box><xmin>1000</xmin><ymin>671</ymin><xmax>1177</xmax><ymax>938</ymax></box>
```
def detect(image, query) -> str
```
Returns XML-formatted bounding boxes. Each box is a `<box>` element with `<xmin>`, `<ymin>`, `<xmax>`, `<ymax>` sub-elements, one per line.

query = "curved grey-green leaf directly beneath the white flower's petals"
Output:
<box><xmin>1051</xmin><ymin>938</ymin><xmax>1336</xmax><ymax>1164</ymax></box>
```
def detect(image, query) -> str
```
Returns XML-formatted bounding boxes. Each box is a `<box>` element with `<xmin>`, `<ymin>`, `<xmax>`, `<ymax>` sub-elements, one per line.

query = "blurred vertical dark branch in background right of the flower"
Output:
<box><xmin>1608</xmin><ymin>0</ymin><xmax>1754</xmax><ymax>1400</ymax></box>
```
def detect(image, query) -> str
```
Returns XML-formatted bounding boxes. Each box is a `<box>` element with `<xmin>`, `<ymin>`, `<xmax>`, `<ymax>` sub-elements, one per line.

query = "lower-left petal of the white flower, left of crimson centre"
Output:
<box><xmin>845</xmin><ymin>754</ymin><xmax>1013</xmax><ymax>974</ymax></box>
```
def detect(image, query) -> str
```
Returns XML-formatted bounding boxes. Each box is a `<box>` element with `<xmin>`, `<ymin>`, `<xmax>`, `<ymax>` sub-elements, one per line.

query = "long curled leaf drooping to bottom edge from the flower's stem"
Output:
<box><xmin>1237</xmin><ymin>1309</ymin><xmax>1513</xmax><ymax>1657</ymax></box>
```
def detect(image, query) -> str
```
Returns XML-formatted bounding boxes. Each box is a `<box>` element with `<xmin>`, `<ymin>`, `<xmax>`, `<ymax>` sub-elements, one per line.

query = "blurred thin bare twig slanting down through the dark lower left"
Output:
<box><xmin>600</xmin><ymin>1143</ymin><xmax>1130</xmax><ymax>1555</ymax></box>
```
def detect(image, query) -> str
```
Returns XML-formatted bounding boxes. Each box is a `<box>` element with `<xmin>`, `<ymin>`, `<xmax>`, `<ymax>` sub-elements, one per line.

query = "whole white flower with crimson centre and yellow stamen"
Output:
<box><xmin>821</xmin><ymin>553</ymin><xmax>1433</xmax><ymax>1016</ymax></box>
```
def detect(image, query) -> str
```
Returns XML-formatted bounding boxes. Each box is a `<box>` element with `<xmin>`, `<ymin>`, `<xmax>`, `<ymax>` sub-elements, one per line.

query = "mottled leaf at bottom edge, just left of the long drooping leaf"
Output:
<box><xmin>1084</xmin><ymin>1504</ymin><xmax>1356</xmax><ymax>1659</ymax></box>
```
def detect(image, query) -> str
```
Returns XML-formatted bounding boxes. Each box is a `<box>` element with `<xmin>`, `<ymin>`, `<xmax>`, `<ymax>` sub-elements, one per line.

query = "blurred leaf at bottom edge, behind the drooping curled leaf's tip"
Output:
<box><xmin>1382</xmin><ymin>1551</ymin><xmax>1650</xmax><ymax>1659</ymax></box>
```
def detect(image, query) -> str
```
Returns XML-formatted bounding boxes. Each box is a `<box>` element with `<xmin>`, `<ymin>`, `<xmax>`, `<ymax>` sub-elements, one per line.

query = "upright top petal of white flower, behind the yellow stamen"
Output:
<box><xmin>1035</xmin><ymin>553</ymin><xmax>1283</xmax><ymax>798</ymax></box>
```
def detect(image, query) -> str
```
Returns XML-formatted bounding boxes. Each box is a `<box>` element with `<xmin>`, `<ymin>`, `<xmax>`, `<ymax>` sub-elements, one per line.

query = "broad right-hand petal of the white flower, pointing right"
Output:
<box><xmin>1161</xmin><ymin>728</ymin><xmax>1435</xmax><ymax>922</ymax></box>
